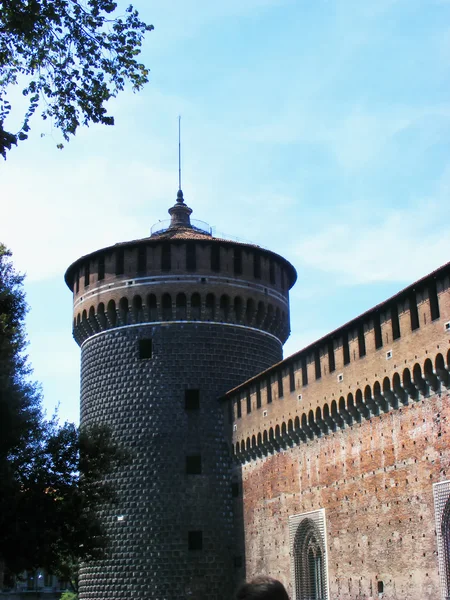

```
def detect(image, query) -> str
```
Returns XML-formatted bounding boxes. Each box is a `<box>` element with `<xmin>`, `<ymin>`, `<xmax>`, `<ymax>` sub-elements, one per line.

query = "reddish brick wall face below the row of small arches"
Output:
<box><xmin>235</xmin><ymin>393</ymin><xmax>450</xmax><ymax>600</ymax></box>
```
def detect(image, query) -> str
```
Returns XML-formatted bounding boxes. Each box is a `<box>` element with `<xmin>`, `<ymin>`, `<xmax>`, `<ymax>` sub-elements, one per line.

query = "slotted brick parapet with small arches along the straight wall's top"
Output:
<box><xmin>223</xmin><ymin>263</ymin><xmax>450</xmax><ymax>462</ymax></box>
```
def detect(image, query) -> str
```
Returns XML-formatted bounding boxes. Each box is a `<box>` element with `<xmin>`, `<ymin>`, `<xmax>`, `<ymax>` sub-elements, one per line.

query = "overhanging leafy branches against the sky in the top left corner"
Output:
<box><xmin>0</xmin><ymin>0</ymin><xmax>153</xmax><ymax>158</ymax></box>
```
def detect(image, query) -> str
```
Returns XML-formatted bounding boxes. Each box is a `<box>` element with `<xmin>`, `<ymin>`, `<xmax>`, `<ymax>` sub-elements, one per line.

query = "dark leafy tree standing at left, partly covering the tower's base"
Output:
<box><xmin>0</xmin><ymin>245</ymin><xmax>122</xmax><ymax>590</ymax></box>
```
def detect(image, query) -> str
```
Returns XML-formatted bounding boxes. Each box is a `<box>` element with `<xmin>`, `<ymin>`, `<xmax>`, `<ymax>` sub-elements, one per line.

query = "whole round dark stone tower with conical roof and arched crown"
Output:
<box><xmin>65</xmin><ymin>190</ymin><xmax>296</xmax><ymax>600</ymax></box>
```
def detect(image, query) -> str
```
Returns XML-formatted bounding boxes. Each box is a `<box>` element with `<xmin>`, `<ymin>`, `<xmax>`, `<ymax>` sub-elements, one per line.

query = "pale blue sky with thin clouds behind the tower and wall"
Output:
<box><xmin>0</xmin><ymin>0</ymin><xmax>450</xmax><ymax>421</ymax></box>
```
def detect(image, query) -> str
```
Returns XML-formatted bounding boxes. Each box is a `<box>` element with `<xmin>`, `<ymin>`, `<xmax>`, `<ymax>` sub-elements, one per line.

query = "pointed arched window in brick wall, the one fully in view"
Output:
<box><xmin>294</xmin><ymin>518</ymin><xmax>326</xmax><ymax>600</ymax></box>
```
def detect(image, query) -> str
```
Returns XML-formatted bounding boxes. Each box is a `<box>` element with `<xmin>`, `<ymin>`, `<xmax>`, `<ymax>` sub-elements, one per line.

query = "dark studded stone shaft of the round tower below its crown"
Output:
<box><xmin>80</xmin><ymin>323</ymin><xmax>281</xmax><ymax>600</ymax></box>
